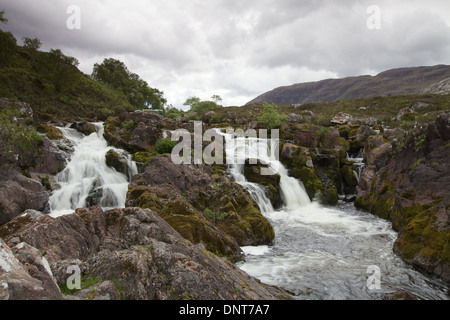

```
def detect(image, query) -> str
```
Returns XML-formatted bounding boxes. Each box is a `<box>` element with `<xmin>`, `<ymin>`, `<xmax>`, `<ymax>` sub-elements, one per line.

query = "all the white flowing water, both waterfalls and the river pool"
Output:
<box><xmin>49</xmin><ymin>123</ymin><xmax>449</xmax><ymax>300</ymax></box>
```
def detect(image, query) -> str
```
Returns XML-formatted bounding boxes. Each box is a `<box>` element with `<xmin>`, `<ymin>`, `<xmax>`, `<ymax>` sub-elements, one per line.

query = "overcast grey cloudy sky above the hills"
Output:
<box><xmin>0</xmin><ymin>0</ymin><xmax>450</xmax><ymax>107</ymax></box>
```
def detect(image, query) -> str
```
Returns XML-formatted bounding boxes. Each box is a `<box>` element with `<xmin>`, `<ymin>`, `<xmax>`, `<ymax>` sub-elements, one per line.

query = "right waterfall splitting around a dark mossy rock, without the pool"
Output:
<box><xmin>222</xmin><ymin>133</ymin><xmax>311</xmax><ymax>213</ymax></box>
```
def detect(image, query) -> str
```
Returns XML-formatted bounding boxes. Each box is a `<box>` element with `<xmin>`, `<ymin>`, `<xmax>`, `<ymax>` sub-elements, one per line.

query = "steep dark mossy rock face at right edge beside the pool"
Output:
<box><xmin>356</xmin><ymin>112</ymin><xmax>450</xmax><ymax>280</ymax></box>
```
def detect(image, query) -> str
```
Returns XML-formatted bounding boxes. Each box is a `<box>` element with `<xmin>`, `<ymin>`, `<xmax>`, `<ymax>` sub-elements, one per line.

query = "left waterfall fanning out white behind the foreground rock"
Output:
<box><xmin>49</xmin><ymin>123</ymin><xmax>137</xmax><ymax>217</ymax></box>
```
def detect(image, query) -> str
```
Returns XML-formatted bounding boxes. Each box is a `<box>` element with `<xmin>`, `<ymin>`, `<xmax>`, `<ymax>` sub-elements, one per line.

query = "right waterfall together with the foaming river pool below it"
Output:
<box><xmin>225</xmin><ymin>130</ymin><xmax>448</xmax><ymax>300</ymax></box>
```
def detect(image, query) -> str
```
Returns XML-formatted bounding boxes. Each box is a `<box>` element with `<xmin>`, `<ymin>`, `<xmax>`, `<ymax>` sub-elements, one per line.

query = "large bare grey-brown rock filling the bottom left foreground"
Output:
<box><xmin>0</xmin><ymin>207</ymin><xmax>290</xmax><ymax>300</ymax></box>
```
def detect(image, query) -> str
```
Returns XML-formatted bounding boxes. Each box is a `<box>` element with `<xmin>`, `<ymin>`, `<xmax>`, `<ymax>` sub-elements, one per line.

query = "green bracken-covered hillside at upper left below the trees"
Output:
<box><xmin>0</xmin><ymin>31</ymin><xmax>135</xmax><ymax>121</ymax></box>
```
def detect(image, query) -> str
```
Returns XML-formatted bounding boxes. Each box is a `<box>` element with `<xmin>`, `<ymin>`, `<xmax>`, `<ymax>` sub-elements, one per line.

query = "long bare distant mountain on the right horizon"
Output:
<box><xmin>247</xmin><ymin>65</ymin><xmax>450</xmax><ymax>104</ymax></box>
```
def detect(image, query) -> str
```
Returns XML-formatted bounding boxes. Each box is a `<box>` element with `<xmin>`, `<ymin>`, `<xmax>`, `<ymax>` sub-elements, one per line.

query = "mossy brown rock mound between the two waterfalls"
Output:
<box><xmin>126</xmin><ymin>155</ymin><xmax>274</xmax><ymax>259</ymax></box>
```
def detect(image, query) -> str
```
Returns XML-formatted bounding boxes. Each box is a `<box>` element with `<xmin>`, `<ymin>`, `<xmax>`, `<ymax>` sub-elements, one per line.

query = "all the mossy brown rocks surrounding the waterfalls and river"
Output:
<box><xmin>0</xmin><ymin>98</ymin><xmax>450</xmax><ymax>299</ymax></box>
